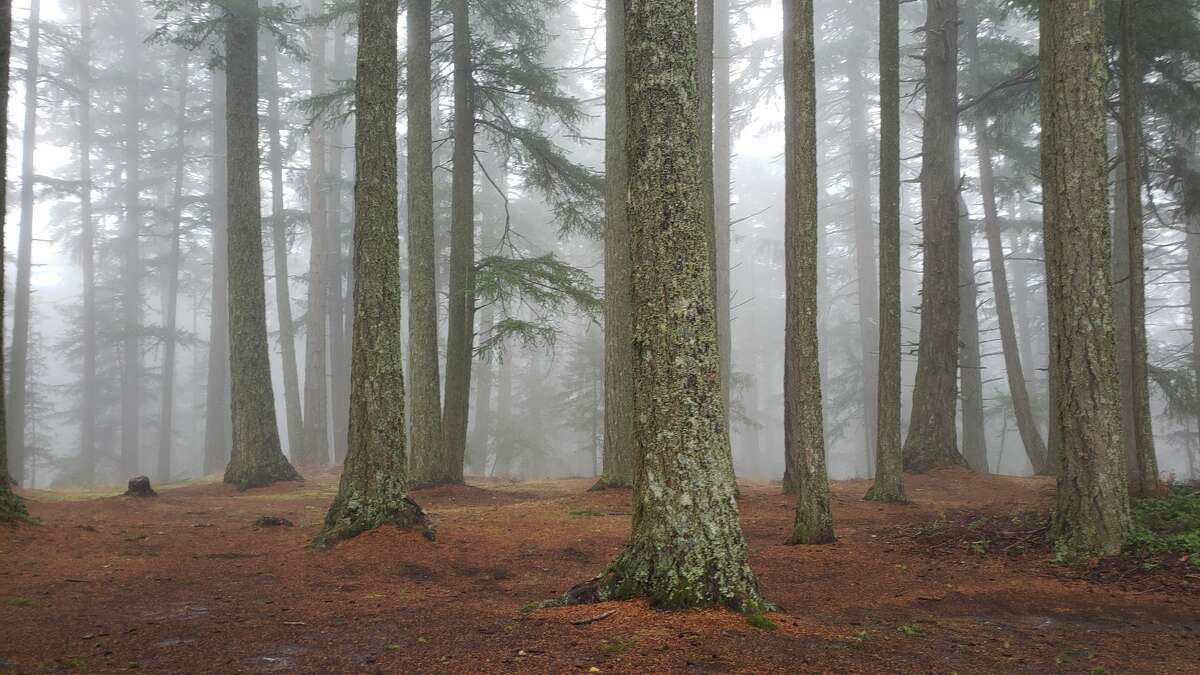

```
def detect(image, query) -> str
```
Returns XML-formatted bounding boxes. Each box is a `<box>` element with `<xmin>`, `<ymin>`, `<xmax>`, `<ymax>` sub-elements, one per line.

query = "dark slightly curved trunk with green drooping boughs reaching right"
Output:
<box><xmin>441</xmin><ymin>0</ymin><xmax>475</xmax><ymax>484</ymax></box>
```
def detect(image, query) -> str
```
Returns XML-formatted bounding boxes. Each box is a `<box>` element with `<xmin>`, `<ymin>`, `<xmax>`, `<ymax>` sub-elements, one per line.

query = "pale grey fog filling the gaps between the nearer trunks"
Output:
<box><xmin>5</xmin><ymin>0</ymin><xmax>1200</xmax><ymax>488</ymax></box>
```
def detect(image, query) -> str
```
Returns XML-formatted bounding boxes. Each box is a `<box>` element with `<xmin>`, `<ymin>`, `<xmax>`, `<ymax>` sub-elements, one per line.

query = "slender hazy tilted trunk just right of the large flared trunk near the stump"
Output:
<box><xmin>263</xmin><ymin>38</ymin><xmax>304</xmax><ymax>456</ymax></box>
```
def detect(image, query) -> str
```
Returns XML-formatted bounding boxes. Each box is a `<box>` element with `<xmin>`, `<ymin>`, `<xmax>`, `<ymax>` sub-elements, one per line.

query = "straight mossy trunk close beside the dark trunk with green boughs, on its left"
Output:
<box><xmin>404</xmin><ymin>0</ymin><xmax>443</xmax><ymax>484</ymax></box>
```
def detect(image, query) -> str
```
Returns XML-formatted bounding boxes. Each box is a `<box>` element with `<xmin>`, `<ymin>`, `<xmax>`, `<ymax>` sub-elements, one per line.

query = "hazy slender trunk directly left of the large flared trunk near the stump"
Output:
<box><xmin>204</xmin><ymin>66</ymin><xmax>233</xmax><ymax>473</ymax></box>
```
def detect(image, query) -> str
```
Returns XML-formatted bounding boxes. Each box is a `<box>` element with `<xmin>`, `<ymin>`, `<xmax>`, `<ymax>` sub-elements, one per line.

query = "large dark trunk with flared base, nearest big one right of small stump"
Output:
<box><xmin>224</xmin><ymin>0</ymin><xmax>300</xmax><ymax>489</ymax></box>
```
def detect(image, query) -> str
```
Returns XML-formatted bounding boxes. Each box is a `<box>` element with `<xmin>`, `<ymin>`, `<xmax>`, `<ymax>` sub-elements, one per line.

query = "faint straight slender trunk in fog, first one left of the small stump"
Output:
<box><xmin>76</xmin><ymin>0</ymin><xmax>100</xmax><ymax>484</ymax></box>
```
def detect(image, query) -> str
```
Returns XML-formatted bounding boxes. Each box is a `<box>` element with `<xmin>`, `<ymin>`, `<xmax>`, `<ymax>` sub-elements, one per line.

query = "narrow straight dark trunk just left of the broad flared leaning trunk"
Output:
<box><xmin>866</xmin><ymin>0</ymin><xmax>906</xmax><ymax>502</ymax></box>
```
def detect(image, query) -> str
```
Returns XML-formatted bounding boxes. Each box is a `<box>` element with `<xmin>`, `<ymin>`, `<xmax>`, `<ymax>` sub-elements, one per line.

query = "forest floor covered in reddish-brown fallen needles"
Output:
<box><xmin>0</xmin><ymin>471</ymin><xmax>1200</xmax><ymax>674</ymax></box>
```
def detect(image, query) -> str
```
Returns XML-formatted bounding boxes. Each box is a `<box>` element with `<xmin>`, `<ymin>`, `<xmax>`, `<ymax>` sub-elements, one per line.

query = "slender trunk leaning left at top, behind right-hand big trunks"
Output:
<box><xmin>964</xmin><ymin>0</ymin><xmax>1046</xmax><ymax>473</ymax></box>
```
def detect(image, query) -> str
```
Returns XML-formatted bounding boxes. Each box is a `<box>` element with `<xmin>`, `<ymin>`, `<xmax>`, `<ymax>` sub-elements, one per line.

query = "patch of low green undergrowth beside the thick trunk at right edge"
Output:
<box><xmin>1126</xmin><ymin>484</ymin><xmax>1200</xmax><ymax>558</ymax></box>
